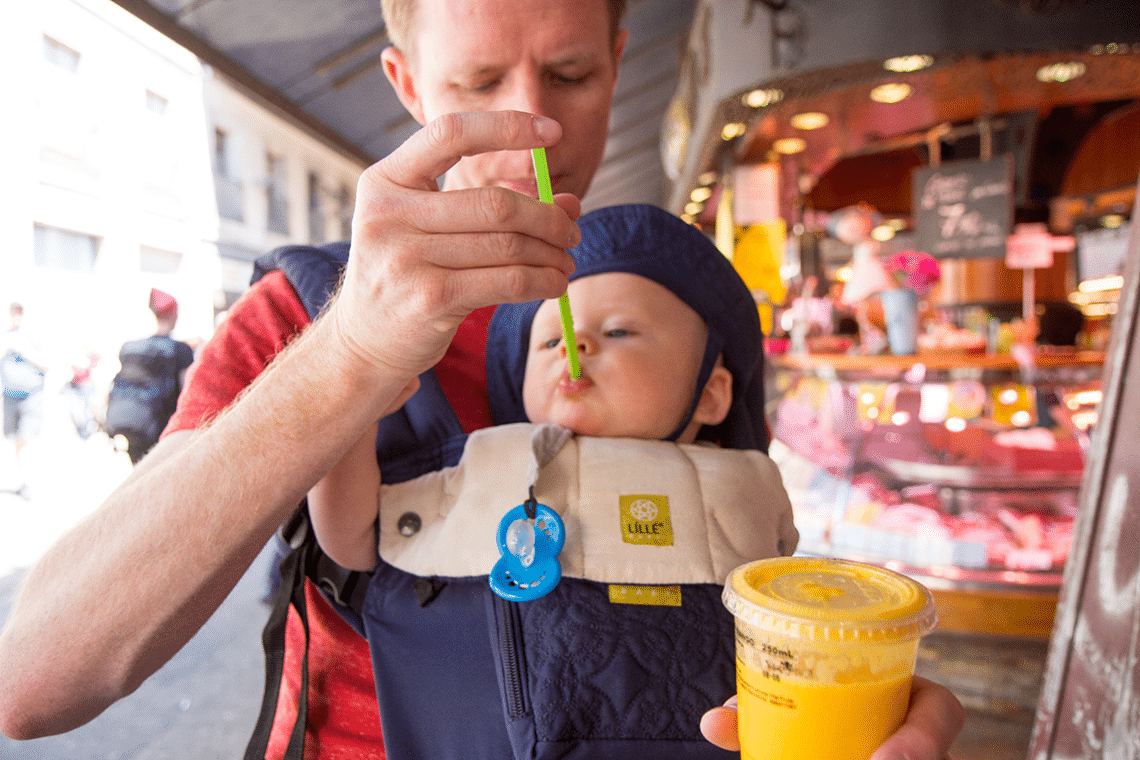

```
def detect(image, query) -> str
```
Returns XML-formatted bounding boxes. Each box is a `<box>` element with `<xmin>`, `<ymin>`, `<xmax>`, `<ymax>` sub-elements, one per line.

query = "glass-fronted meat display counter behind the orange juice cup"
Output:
<box><xmin>767</xmin><ymin>350</ymin><xmax>1104</xmax><ymax>716</ymax></box>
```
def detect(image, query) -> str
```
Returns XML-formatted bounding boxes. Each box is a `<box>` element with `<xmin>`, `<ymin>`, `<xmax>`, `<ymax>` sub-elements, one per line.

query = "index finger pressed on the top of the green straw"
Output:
<box><xmin>361</xmin><ymin>111</ymin><xmax>562</xmax><ymax>198</ymax></box>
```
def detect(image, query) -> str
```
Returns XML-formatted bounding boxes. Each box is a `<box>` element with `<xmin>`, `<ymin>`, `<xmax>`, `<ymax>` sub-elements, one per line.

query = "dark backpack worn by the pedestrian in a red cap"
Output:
<box><xmin>105</xmin><ymin>335</ymin><xmax>194</xmax><ymax>441</ymax></box>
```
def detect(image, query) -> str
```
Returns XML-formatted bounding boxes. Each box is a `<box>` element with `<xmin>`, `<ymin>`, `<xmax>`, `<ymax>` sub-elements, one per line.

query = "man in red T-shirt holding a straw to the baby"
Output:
<box><xmin>0</xmin><ymin>0</ymin><xmax>958</xmax><ymax>760</ymax></box>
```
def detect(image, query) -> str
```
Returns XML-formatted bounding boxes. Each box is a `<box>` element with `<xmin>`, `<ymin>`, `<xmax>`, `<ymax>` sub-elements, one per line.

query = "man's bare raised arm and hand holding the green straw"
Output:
<box><xmin>0</xmin><ymin>112</ymin><xmax>579</xmax><ymax>738</ymax></box>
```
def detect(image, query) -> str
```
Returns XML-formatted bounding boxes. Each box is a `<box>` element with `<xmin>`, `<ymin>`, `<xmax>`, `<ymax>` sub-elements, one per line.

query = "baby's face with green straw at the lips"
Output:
<box><xmin>522</xmin><ymin>272</ymin><xmax>708</xmax><ymax>442</ymax></box>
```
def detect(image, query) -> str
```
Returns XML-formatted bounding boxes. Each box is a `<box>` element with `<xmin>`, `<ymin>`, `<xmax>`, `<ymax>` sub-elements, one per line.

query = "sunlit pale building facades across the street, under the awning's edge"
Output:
<box><xmin>0</xmin><ymin>0</ymin><xmax>363</xmax><ymax>371</ymax></box>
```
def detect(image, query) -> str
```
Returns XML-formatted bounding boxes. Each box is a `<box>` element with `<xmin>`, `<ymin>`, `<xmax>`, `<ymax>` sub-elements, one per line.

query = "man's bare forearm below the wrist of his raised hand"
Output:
<box><xmin>0</xmin><ymin>307</ymin><xmax>408</xmax><ymax>737</ymax></box>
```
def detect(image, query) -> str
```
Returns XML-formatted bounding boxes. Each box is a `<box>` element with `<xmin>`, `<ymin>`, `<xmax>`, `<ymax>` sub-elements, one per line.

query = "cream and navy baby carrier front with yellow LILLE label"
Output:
<box><xmin>364</xmin><ymin>424</ymin><xmax>796</xmax><ymax>760</ymax></box>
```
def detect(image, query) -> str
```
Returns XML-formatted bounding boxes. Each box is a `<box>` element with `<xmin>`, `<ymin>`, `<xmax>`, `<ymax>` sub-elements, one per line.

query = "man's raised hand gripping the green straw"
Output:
<box><xmin>329</xmin><ymin>112</ymin><xmax>580</xmax><ymax>377</ymax></box>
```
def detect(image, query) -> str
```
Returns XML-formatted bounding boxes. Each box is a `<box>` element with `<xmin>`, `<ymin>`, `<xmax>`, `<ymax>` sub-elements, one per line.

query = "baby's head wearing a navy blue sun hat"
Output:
<box><xmin>487</xmin><ymin>205</ymin><xmax>767</xmax><ymax>450</ymax></box>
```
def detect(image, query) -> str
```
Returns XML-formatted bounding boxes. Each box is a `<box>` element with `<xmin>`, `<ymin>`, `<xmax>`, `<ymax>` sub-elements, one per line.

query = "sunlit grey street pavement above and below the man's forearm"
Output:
<box><xmin>0</xmin><ymin>401</ymin><xmax>271</xmax><ymax>760</ymax></box>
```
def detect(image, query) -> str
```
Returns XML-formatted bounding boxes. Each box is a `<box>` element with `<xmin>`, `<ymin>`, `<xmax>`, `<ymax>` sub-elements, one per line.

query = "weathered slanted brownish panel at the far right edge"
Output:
<box><xmin>1029</xmin><ymin>181</ymin><xmax>1140</xmax><ymax>760</ymax></box>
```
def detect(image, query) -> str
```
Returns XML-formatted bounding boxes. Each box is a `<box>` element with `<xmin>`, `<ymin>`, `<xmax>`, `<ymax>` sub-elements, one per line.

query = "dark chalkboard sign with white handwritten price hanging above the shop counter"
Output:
<box><xmin>911</xmin><ymin>155</ymin><xmax>1013</xmax><ymax>259</ymax></box>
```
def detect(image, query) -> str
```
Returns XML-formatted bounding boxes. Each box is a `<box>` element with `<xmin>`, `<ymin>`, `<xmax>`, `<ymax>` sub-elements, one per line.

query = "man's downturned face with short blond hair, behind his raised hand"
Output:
<box><xmin>392</xmin><ymin>0</ymin><xmax>625</xmax><ymax>197</ymax></box>
